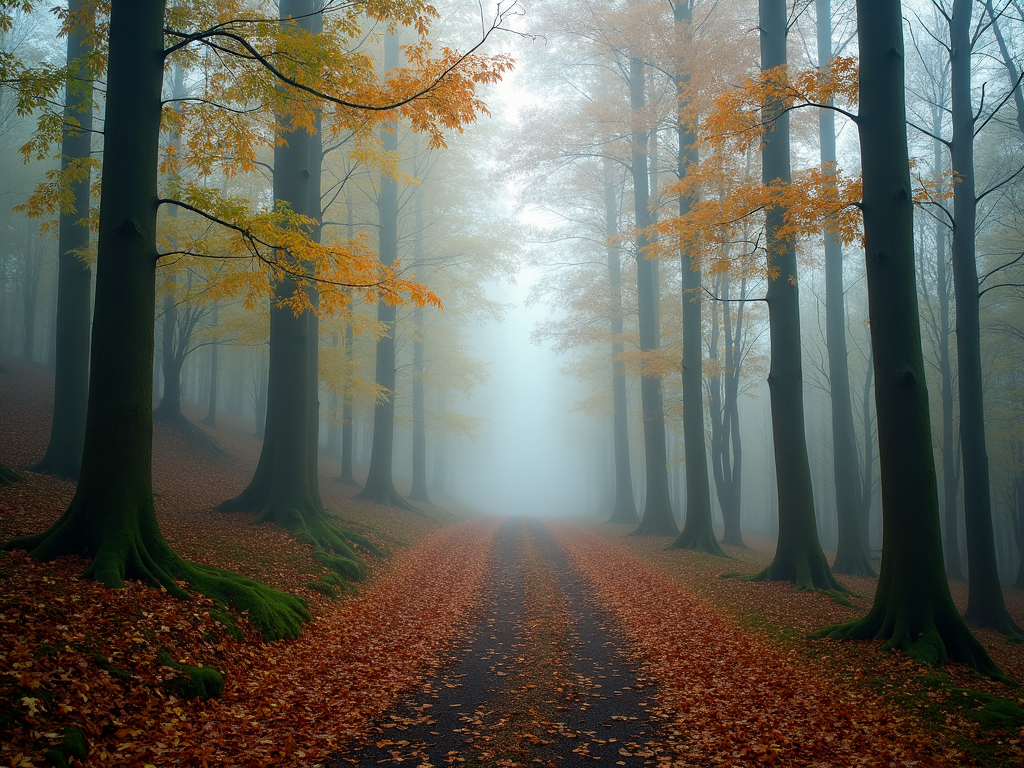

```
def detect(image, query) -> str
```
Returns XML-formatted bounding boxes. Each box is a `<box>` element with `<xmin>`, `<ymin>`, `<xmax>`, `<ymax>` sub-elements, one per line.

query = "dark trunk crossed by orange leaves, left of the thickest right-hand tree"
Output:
<box><xmin>754</xmin><ymin>0</ymin><xmax>846</xmax><ymax>592</ymax></box>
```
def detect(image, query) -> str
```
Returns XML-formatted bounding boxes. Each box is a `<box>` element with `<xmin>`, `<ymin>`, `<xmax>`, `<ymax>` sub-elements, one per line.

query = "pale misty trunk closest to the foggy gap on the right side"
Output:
<box><xmin>602</xmin><ymin>158</ymin><xmax>640</xmax><ymax>525</ymax></box>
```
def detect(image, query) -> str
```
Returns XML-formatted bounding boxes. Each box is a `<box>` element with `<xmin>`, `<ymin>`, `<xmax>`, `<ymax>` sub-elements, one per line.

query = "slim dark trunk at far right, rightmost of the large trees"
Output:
<box><xmin>949</xmin><ymin>0</ymin><xmax>1024</xmax><ymax>637</ymax></box>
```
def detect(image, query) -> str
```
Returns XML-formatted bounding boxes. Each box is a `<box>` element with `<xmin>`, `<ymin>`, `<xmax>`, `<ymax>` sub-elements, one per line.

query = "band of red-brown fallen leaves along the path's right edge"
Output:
<box><xmin>552</xmin><ymin>526</ymin><xmax>953</xmax><ymax>766</ymax></box>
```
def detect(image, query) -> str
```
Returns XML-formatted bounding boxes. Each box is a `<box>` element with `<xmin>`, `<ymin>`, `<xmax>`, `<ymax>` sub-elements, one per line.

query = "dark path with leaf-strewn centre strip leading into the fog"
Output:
<box><xmin>338</xmin><ymin>519</ymin><xmax>660</xmax><ymax>766</ymax></box>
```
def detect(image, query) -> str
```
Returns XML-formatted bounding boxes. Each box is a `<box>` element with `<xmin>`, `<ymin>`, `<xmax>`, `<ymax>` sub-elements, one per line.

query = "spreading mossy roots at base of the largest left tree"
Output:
<box><xmin>3</xmin><ymin>512</ymin><xmax>310</xmax><ymax>640</ymax></box>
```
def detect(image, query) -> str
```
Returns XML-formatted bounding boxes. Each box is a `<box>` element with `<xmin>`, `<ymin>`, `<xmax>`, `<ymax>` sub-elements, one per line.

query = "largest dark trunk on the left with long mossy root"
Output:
<box><xmin>6</xmin><ymin>0</ymin><xmax>309</xmax><ymax>636</ymax></box>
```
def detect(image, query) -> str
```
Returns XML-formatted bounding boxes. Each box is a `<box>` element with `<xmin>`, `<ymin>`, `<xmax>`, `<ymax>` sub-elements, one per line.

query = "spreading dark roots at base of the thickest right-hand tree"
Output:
<box><xmin>810</xmin><ymin>599</ymin><xmax>1007</xmax><ymax>681</ymax></box>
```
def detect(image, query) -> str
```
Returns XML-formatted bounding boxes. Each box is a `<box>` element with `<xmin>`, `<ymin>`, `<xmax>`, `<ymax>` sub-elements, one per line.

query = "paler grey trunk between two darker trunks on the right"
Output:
<box><xmin>816</xmin><ymin>0</ymin><xmax>874</xmax><ymax>577</ymax></box>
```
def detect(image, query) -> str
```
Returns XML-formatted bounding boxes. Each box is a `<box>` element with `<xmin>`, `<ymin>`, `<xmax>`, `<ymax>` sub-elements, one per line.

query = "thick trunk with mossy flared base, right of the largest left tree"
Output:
<box><xmin>218</xmin><ymin>0</ymin><xmax>373</xmax><ymax>579</ymax></box>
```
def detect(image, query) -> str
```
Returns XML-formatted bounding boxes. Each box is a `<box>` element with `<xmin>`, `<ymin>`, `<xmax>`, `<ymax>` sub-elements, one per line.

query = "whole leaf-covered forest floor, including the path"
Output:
<box><xmin>0</xmin><ymin>358</ymin><xmax>1024</xmax><ymax>766</ymax></box>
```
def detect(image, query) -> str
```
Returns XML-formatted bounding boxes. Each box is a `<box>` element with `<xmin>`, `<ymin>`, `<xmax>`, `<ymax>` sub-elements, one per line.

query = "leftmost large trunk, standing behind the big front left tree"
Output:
<box><xmin>32</xmin><ymin>0</ymin><xmax>93</xmax><ymax>480</ymax></box>
